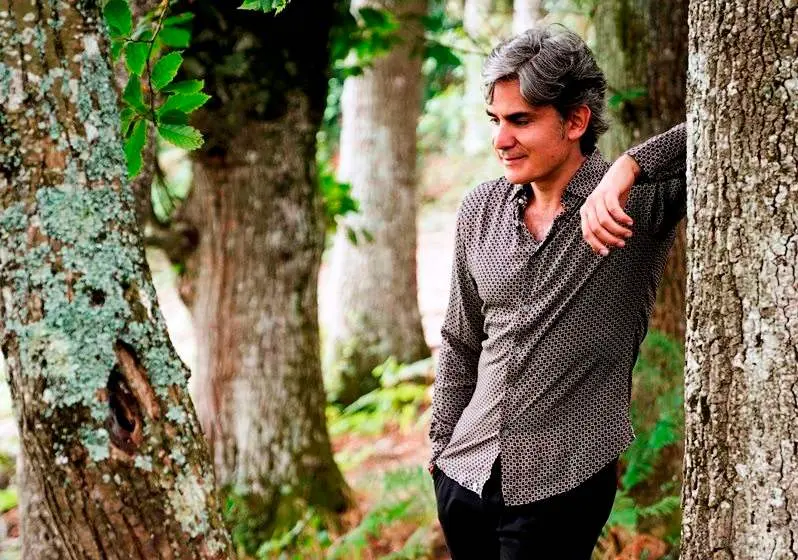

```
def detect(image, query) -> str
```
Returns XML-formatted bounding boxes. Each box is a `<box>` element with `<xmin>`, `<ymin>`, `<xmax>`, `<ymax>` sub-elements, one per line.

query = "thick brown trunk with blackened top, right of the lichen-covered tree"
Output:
<box><xmin>181</xmin><ymin>0</ymin><xmax>347</xmax><ymax>548</ymax></box>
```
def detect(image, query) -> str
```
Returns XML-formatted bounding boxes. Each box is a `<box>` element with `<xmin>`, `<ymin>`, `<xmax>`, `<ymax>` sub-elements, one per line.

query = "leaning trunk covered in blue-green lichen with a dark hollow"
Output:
<box><xmin>0</xmin><ymin>0</ymin><xmax>229</xmax><ymax>560</ymax></box>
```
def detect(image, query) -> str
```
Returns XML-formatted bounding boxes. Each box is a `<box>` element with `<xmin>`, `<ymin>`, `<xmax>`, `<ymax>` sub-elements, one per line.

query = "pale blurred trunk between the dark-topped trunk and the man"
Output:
<box><xmin>325</xmin><ymin>0</ymin><xmax>430</xmax><ymax>403</ymax></box>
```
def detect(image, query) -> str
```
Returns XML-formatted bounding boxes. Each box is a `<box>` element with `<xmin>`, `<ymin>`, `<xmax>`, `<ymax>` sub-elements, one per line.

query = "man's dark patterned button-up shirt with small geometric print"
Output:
<box><xmin>430</xmin><ymin>124</ymin><xmax>686</xmax><ymax>505</ymax></box>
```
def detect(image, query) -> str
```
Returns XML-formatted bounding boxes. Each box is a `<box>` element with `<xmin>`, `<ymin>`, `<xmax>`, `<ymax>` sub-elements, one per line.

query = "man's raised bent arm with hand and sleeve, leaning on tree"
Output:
<box><xmin>580</xmin><ymin>123</ymin><xmax>687</xmax><ymax>255</ymax></box>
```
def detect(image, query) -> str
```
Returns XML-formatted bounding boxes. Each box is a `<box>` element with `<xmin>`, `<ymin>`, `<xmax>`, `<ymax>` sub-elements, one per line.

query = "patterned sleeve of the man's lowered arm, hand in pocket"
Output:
<box><xmin>429</xmin><ymin>200</ymin><xmax>486</xmax><ymax>463</ymax></box>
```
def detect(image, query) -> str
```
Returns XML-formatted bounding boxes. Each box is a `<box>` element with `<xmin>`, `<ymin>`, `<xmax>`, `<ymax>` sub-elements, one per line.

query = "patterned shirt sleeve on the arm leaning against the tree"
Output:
<box><xmin>625</xmin><ymin>123</ymin><xmax>687</xmax><ymax>234</ymax></box>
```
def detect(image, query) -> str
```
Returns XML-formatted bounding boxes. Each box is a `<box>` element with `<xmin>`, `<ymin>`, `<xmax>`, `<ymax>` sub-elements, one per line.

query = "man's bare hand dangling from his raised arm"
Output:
<box><xmin>579</xmin><ymin>155</ymin><xmax>640</xmax><ymax>256</ymax></box>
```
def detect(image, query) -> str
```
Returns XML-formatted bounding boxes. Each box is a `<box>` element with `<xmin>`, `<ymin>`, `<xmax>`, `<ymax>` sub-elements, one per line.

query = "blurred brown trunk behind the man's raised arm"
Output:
<box><xmin>593</xmin><ymin>0</ymin><xmax>687</xmax><ymax>341</ymax></box>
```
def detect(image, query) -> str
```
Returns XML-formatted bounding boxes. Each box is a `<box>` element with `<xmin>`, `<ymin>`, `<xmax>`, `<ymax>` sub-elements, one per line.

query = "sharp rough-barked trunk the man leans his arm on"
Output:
<box><xmin>682</xmin><ymin>0</ymin><xmax>798</xmax><ymax>560</ymax></box>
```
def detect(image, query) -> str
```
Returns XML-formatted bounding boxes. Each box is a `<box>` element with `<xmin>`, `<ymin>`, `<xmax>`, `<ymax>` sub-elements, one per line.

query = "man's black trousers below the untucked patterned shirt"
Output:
<box><xmin>433</xmin><ymin>459</ymin><xmax>618</xmax><ymax>560</ymax></box>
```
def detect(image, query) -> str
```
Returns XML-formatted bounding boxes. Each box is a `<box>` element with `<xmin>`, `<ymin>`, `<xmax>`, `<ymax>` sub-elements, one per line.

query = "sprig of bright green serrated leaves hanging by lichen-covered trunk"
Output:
<box><xmin>103</xmin><ymin>0</ymin><xmax>210</xmax><ymax>178</ymax></box>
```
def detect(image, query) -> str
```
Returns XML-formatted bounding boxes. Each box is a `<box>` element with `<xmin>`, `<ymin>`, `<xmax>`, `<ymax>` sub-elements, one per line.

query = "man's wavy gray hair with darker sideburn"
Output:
<box><xmin>482</xmin><ymin>25</ymin><xmax>609</xmax><ymax>155</ymax></box>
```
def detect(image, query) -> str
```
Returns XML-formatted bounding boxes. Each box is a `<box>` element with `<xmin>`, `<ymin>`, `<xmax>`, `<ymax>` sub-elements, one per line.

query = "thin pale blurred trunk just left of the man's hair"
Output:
<box><xmin>461</xmin><ymin>0</ymin><xmax>496</xmax><ymax>155</ymax></box>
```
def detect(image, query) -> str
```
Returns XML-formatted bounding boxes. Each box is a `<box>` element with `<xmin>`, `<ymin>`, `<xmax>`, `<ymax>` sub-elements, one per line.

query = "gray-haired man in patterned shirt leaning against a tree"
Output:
<box><xmin>430</xmin><ymin>24</ymin><xmax>686</xmax><ymax>560</ymax></box>
